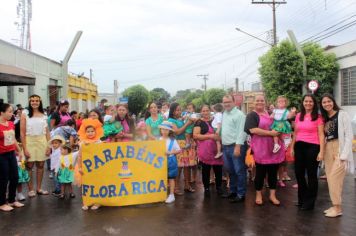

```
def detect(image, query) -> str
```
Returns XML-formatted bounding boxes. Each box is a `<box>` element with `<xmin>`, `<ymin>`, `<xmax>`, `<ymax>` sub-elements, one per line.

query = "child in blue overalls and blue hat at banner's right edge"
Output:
<box><xmin>158</xmin><ymin>121</ymin><xmax>181</xmax><ymax>203</ymax></box>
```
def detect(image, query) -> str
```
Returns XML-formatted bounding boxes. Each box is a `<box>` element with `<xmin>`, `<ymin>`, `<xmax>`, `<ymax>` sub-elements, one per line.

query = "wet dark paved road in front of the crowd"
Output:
<box><xmin>0</xmin><ymin>170</ymin><xmax>356</xmax><ymax>236</ymax></box>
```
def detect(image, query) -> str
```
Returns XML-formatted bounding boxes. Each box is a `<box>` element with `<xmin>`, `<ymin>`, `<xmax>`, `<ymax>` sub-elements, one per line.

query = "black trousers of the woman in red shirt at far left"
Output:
<box><xmin>0</xmin><ymin>151</ymin><xmax>19</xmax><ymax>206</ymax></box>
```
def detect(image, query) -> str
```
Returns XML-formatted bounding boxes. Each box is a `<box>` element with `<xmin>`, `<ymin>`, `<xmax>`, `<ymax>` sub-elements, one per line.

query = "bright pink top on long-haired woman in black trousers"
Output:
<box><xmin>295</xmin><ymin>113</ymin><xmax>324</xmax><ymax>144</ymax></box>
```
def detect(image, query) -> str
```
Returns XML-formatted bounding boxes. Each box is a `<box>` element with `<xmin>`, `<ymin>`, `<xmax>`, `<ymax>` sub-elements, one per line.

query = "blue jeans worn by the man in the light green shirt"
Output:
<box><xmin>223</xmin><ymin>145</ymin><xmax>247</xmax><ymax>197</ymax></box>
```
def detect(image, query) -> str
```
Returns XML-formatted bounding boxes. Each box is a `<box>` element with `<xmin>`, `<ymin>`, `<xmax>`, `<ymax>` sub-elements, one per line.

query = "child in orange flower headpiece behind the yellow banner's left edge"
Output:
<box><xmin>75</xmin><ymin>118</ymin><xmax>104</xmax><ymax>211</ymax></box>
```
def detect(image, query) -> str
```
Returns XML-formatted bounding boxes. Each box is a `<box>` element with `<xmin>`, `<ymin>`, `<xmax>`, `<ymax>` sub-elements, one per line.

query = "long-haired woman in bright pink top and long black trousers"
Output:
<box><xmin>291</xmin><ymin>94</ymin><xmax>324</xmax><ymax>211</ymax></box>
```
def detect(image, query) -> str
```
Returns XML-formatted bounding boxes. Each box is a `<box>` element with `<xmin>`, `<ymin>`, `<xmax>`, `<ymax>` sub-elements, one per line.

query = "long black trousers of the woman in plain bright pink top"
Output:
<box><xmin>294</xmin><ymin>141</ymin><xmax>320</xmax><ymax>208</ymax></box>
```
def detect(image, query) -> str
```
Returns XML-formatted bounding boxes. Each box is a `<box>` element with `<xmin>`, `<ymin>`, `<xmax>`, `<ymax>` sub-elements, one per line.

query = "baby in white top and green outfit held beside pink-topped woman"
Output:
<box><xmin>271</xmin><ymin>96</ymin><xmax>296</xmax><ymax>153</ymax></box>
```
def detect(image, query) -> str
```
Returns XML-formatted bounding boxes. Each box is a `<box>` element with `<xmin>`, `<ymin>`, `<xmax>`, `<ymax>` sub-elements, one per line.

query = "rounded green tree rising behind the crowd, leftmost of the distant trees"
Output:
<box><xmin>123</xmin><ymin>85</ymin><xmax>149</xmax><ymax>115</ymax></box>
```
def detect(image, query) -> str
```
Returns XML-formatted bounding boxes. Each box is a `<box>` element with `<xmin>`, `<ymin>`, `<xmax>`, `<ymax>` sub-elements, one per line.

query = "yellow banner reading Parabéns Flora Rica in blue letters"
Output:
<box><xmin>82</xmin><ymin>141</ymin><xmax>167</xmax><ymax>206</ymax></box>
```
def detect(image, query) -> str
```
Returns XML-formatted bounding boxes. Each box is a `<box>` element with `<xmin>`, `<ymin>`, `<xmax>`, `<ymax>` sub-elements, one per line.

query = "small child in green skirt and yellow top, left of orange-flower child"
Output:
<box><xmin>56</xmin><ymin>143</ymin><xmax>78</xmax><ymax>199</ymax></box>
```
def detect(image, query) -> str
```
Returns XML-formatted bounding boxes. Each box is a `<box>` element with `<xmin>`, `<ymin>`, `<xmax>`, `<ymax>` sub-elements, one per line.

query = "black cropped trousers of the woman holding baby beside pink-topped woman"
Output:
<box><xmin>255</xmin><ymin>163</ymin><xmax>279</xmax><ymax>191</ymax></box>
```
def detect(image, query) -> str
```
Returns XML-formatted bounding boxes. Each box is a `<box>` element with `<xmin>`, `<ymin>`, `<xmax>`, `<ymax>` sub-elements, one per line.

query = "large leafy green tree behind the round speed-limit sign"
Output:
<box><xmin>259</xmin><ymin>40</ymin><xmax>338</xmax><ymax>106</ymax></box>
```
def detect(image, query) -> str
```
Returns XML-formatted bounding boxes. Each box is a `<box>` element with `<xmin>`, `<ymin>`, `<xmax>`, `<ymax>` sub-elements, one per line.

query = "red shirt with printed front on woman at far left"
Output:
<box><xmin>0</xmin><ymin>121</ymin><xmax>16</xmax><ymax>154</ymax></box>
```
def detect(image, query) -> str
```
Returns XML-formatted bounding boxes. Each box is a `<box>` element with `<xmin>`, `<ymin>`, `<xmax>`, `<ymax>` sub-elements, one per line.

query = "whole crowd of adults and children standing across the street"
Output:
<box><xmin>0</xmin><ymin>94</ymin><xmax>355</xmax><ymax>217</ymax></box>
